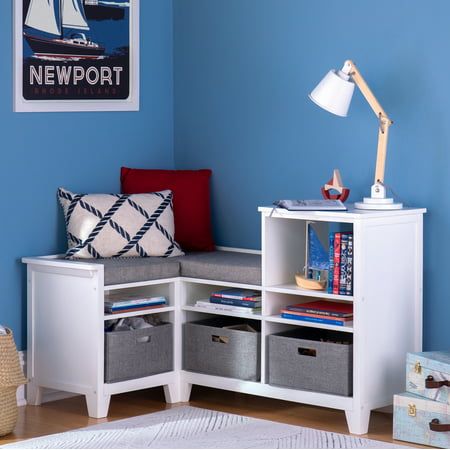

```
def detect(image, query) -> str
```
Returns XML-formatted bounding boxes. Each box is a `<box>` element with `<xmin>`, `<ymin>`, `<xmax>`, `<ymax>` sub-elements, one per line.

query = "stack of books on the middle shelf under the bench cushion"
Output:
<box><xmin>195</xmin><ymin>288</ymin><xmax>261</xmax><ymax>314</ymax></box>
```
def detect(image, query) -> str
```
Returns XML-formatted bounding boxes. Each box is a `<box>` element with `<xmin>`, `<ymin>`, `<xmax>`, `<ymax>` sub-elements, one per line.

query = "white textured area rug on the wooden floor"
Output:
<box><xmin>1</xmin><ymin>406</ymin><xmax>407</xmax><ymax>449</ymax></box>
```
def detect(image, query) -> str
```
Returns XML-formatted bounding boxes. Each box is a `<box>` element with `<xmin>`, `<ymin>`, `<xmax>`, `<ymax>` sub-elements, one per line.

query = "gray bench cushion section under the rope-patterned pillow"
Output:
<box><xmin>88</xmin><ymin>257</ymin><xmax>180</xmax><ymax>286</ymax></box>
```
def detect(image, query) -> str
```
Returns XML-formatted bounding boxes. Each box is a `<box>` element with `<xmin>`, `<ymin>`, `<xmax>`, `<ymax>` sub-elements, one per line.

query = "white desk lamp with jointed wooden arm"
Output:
<box><xmin>309</xmin><ymin>60</ymin><xmax>403</xmax><ymax>209</ymax></box>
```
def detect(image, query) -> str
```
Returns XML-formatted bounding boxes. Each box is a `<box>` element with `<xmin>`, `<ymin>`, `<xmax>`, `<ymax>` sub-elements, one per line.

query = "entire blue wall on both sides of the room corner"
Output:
<box><xmin>4</xmin><ymin>0</ymin><xmax>450</xmax><ymax>349</ymax></box>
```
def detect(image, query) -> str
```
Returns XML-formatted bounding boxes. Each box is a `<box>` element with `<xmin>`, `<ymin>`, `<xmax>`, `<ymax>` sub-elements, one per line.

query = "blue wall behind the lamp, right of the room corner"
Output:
<box><xmin>174</xmin><ymin>0</ymin><xmax>450</xmax><ymax>349</ymax></box>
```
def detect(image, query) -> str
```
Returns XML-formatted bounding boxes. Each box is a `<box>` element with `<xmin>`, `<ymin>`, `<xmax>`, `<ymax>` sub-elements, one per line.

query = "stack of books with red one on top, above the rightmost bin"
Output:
<box><xmin>281</xmin><ymin>300</ymin><xmax>353</xmax><ymax>326</ymax></box>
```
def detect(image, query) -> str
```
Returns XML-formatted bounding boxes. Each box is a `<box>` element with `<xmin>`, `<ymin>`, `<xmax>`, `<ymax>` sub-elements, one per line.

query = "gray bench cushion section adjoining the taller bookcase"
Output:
<box><xmin>176</xmin><ymin>251</ymin><xmax>261</xmax><ymax>286</ymax></box>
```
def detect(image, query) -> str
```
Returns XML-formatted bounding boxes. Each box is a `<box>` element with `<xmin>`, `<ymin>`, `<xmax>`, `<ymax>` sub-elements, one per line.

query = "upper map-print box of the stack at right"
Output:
<box><xmin>406</xmin><ymin>352</ymin><xmax>450</xmax><ymax>405</ymax></box>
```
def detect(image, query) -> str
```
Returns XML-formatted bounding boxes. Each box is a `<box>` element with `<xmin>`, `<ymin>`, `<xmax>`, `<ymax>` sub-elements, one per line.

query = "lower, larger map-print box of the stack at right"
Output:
<box><xmin>393</xmin><ymin>392</ymin><xmax>450</xmax><ymax>448</ymax></box>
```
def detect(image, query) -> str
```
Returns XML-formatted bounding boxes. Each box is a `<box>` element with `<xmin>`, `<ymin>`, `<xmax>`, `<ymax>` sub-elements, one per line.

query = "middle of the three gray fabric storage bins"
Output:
<box><xmin>183</xmin><ymin>317</ymin><xmax>261</xmax><ymax>381</ymax></box>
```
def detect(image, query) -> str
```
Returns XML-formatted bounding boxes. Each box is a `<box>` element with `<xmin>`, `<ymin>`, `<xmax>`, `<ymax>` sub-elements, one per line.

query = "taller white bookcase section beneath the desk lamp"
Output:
<box><xmin>259</xmin><ymin>208</ymin><xmax>426</xmax><ymax>434</ymax></box>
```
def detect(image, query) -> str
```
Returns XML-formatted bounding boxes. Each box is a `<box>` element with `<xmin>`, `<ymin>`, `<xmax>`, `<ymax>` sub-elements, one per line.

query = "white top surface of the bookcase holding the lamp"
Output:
<box><xmin>258</xmin><ymin>204</ymin><xmax>427</xmax><ymax>222</ymax></box>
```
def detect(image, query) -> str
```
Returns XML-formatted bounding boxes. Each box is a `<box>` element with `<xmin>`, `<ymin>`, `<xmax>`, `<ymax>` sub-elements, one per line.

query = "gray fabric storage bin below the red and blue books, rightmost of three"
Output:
<box><xmin>268</xmin><ymin>327</ymin><xmax>353</xmax><ymax>396</ymax></box>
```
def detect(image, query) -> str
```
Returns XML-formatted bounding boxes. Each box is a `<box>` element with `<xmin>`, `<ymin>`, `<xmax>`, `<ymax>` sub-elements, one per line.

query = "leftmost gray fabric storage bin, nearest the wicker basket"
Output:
<box><xmin>105</xmin><ymin>323</ymin><xmax>173</xmax><ymax>383</ymax></box>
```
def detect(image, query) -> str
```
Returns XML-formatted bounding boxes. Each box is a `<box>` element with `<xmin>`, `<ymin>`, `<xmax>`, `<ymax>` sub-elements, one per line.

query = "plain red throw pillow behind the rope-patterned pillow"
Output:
<box><xmin>120</xmin><ymin>167</ymin><xmax>215</xmax><ymax>251</ymax></box>
